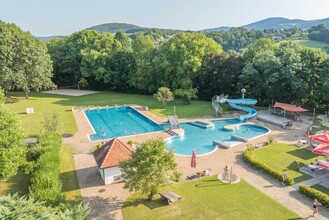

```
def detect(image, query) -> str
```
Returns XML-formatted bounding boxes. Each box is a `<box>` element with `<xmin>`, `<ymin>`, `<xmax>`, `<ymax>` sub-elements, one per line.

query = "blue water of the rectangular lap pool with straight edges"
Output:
<box><xmin>85</xmin><ymin>106</ymin><xmax>163</xmax><ymax>141</ymax></box>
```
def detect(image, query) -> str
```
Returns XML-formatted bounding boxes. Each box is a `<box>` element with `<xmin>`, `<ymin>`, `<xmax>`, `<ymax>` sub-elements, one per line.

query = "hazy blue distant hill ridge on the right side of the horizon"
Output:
<box><xmin>202</xmin><ymin>17</ymin><xmax>329</xmax><ymax>32</ymax></box>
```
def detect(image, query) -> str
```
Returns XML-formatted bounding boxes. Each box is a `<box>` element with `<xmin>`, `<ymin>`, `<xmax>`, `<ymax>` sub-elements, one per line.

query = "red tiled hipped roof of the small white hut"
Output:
<box><xmin>93</xmin><ymin>138</ymin><xmax>133</xmax><ymax>169</ymax></box>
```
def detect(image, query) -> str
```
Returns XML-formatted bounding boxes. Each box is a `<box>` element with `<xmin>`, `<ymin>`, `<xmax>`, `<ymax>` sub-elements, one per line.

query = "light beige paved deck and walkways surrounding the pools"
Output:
<box><xmin>63</xmin><ymin>105</ymin><xmax>329</xmax><ymax>219</ymax></box>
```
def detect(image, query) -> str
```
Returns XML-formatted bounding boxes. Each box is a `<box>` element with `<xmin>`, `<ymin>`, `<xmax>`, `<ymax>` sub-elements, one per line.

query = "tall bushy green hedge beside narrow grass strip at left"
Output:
<box><xmin>29</xmin><ymin>133</ymin><xmax>64</xmax><ymax>206</ymax></box>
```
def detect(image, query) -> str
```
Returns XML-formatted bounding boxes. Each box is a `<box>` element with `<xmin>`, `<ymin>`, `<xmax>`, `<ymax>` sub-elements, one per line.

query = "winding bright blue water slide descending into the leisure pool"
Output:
<box><xmin>226</xmin><ymin>99</ymin><xmax>257</xmax><ymax>121</ymax></box>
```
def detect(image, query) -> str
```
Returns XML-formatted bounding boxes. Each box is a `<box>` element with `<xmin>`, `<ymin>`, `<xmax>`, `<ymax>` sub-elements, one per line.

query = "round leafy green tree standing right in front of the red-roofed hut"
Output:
<box><xmin>119</xmin><ymin>139</ymin><xmax>177</xmax><ymax>200</ymax></box>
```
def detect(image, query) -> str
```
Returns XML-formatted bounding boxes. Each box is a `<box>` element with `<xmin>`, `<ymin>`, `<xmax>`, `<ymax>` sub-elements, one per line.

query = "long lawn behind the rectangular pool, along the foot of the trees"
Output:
<box><xmin>6</xmin><ymin>92</ymin><xmax>215</xmax><ymax>136</ymax></box>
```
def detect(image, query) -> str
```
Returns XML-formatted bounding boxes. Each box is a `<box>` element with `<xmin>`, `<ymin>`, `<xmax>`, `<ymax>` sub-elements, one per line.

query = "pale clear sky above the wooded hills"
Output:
<box><xmin>0</xmin><ymin>0</ymin><xmax>329</xmax><ymax>36</ymax></box>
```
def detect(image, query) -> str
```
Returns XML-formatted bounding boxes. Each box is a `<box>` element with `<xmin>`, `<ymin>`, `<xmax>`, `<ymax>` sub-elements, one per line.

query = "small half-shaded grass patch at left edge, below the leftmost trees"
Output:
<box><xmin>0</xmin><ymin>173</ymin><xmax>30</xmax><ymax>196</ymax></box>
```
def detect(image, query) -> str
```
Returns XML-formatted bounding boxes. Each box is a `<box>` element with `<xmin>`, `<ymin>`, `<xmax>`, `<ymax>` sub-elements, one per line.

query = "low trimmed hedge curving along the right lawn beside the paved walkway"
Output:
<box><xmin>243</xmin><ymin>148</ymin><xmax>295</xmax><ymax>185</ymax></box>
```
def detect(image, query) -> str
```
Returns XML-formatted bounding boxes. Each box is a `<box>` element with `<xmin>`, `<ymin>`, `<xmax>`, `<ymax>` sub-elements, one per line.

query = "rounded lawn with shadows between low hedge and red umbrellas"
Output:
<box><xmin>254</xmin><ymin>143</ymin><xmax>323</xmax><ymax>183</ymax></box>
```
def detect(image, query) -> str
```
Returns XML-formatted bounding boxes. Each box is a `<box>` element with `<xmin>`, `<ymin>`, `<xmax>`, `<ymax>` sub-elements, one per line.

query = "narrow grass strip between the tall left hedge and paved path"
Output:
<box><xmin>60</xmin><ymin>146</ymin><xmax>82</xmax><ymax>203</ymax></box>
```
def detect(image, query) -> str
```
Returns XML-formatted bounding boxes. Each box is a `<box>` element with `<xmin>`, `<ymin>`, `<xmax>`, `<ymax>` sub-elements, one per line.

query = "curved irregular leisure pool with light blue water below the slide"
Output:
<box><xmin>166</xmin><ymin>119</ymin><xmax>269</xmax><ymax>156</ymax></box>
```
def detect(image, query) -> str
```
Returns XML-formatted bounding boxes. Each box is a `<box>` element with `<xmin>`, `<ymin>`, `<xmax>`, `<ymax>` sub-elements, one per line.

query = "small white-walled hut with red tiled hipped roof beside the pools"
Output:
<box><xmin>93</xmin><ymin>138</ymin><xmax>133</xmax><ymax>185</ymax></box>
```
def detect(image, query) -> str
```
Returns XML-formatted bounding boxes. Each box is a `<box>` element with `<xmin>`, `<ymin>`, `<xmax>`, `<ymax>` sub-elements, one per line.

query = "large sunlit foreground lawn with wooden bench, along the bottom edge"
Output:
<box><xmin>123</xmin><ymin>176</ymin><xmax>300</xmax><ymax>220</ymax></box>
